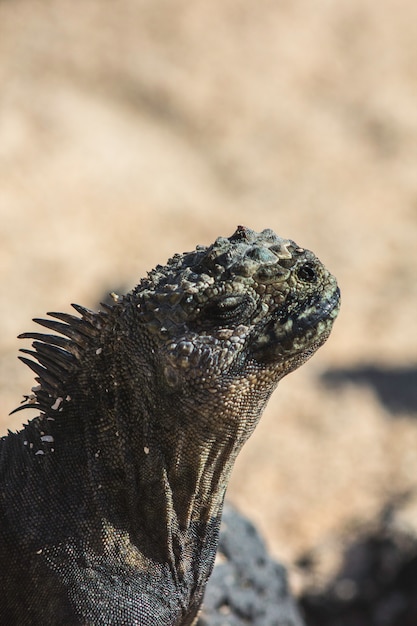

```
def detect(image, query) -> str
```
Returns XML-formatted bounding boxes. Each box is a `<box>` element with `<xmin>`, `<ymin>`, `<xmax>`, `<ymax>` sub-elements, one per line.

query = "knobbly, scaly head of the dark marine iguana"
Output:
<box><xmin>133</xmin><ymin>226</ymin><xmax>340</xmax><ymax>414</ymax></box>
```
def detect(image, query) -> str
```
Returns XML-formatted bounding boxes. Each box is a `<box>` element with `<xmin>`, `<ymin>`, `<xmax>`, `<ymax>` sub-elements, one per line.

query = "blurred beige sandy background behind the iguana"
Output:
<box><xmin>0</xmin><ymin>0</ymin><xmax>417</xmax><ymax>587</ymax></box>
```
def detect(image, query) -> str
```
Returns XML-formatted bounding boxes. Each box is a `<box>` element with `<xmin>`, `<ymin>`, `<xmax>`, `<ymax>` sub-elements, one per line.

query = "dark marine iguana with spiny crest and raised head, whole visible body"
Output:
<box><xmin>0</xmin><ymin>226</ymin><xmax>340</xmax><ymax>626</ymax></box>
